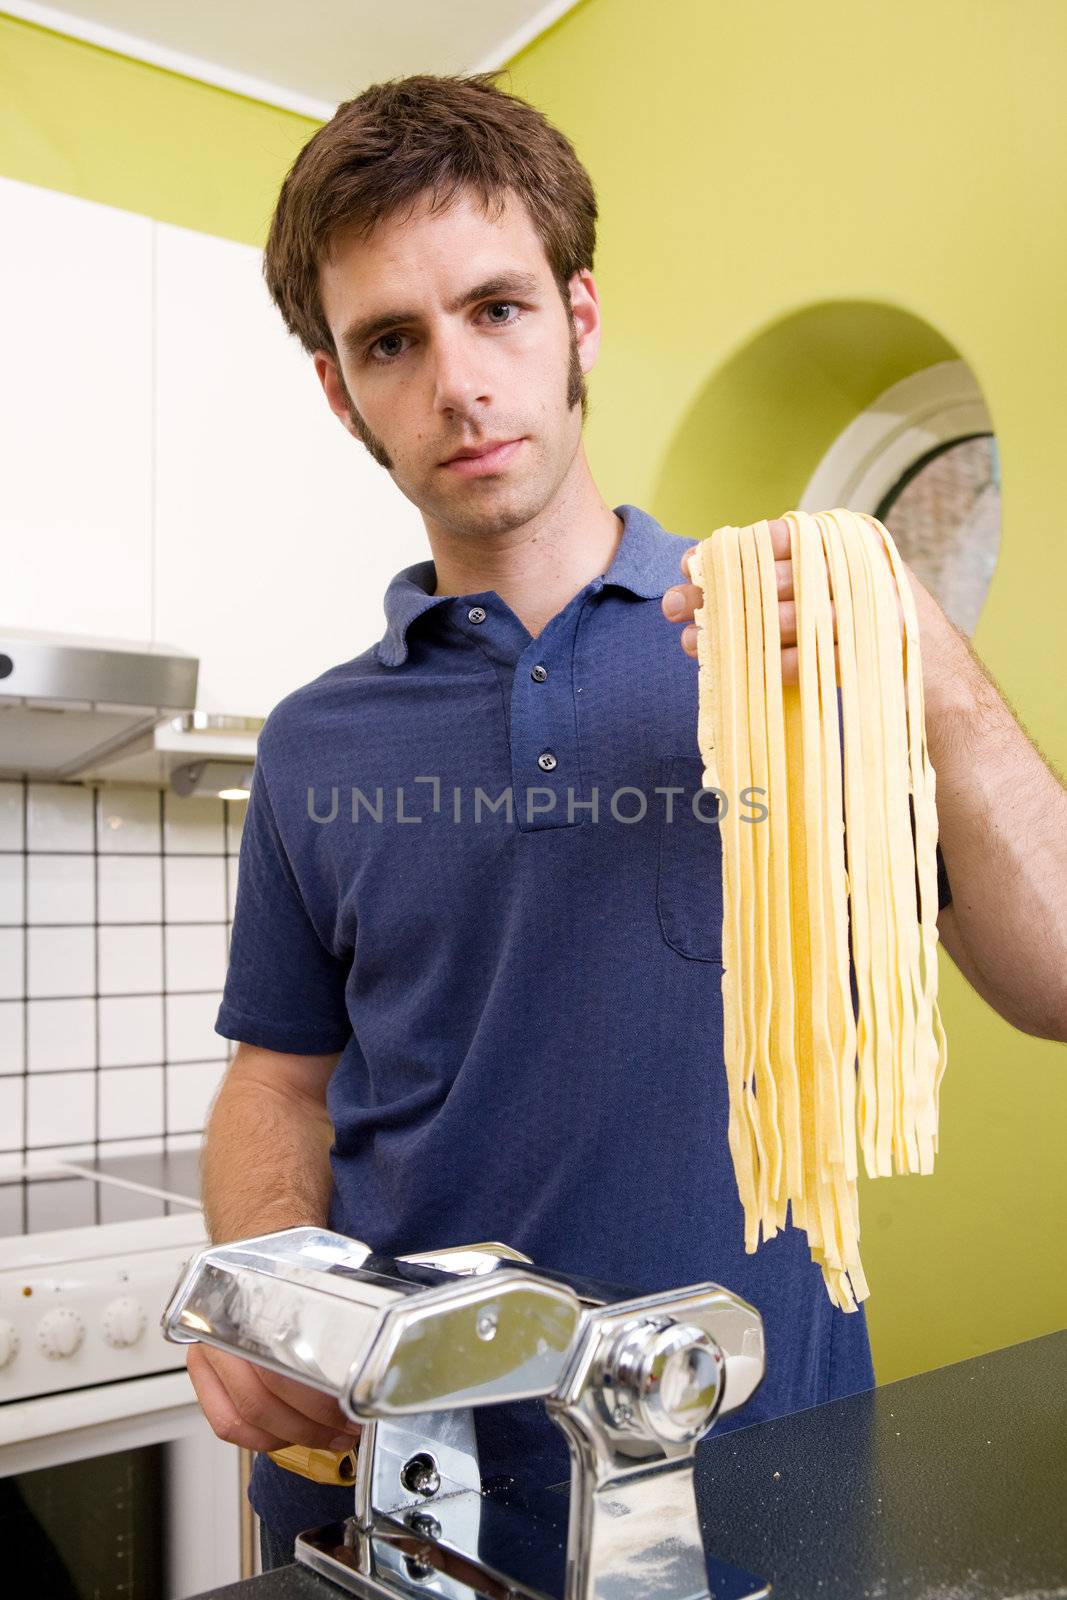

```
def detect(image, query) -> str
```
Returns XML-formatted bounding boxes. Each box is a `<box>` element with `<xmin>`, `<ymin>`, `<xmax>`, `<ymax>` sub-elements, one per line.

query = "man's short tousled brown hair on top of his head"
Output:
<box><xmin>264</xmin><ymin>69</ymin><xmax>597</xmax><ymax>358</ymax></box>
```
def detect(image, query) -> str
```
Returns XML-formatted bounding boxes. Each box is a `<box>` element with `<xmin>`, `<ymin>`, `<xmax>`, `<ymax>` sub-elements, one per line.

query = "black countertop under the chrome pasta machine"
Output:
<box><xmin>191</xmin><ymin>1331</ymin><xmax>1067</xmax><ymax>1600</ymax></box>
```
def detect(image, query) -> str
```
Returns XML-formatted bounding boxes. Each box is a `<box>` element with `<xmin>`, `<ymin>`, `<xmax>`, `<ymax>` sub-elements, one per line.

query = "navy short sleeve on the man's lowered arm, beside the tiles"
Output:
<box><xmin>214</xmin><ymin>760</ymin><xmax>352</xmax><ymax>1056</ymax></box>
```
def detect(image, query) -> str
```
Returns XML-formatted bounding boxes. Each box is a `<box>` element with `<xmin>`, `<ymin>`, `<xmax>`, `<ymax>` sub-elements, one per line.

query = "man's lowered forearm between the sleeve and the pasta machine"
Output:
<box><xmin>202</xmin><ymin>1067</ymin><xmax>333</xmax><ymax>1243</ymax></box>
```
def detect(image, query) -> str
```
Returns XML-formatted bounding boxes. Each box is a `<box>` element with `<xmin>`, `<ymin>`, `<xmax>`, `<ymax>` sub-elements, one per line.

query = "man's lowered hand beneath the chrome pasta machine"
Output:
<box><xmin>186</xmin><ymin>1344</ymin><xmax>363</xmax><ymax>1451</ymax></box>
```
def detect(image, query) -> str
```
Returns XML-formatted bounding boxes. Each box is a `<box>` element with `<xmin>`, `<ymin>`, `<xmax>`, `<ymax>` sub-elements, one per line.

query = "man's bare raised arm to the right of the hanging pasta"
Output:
<box><xmin>917</xmin><ymin>576</ymin><xmax>1067</xmax><ymax>1038</ymax></box>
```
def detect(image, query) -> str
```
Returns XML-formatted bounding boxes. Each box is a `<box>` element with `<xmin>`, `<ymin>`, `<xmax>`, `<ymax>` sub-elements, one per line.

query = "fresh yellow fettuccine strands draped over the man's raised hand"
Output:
<box><xmin>693</xmin><ymin>510</ymin><xmax>945</xmax><ymax>1310</ymax></box>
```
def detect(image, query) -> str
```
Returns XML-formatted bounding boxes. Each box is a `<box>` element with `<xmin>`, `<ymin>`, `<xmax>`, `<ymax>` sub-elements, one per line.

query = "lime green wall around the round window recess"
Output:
<box><xmin>0</xmin><ymin>0</ymin><xmax>1067</xmax><ymax>1382</ymax></box>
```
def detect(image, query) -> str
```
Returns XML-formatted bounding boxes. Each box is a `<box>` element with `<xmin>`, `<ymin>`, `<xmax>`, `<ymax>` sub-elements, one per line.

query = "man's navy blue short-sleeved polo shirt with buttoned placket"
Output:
<box><xmin>216</xmin><ymin>506</ymin><xmax>873</xmax><ymax>1533</ymax></box>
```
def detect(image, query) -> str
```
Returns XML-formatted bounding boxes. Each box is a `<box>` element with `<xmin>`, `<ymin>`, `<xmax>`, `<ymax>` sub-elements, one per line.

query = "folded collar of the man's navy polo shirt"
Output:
<box><xmin>378</xmin><ymin>506</ymin><xmax>683</xmax><ymax>667</ymax></box>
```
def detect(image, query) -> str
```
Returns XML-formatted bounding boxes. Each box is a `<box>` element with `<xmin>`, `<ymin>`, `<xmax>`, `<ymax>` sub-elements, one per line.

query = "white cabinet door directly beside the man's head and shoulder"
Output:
<box><xmin>154</xmin><ymin>224</ymin><xmax>429</xmax><ymax>715</ymax></box>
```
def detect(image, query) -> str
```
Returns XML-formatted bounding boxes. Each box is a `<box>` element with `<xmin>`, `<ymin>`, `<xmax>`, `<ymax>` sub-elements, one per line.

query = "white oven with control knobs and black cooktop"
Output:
<box><xmin>0</xmin><ymin>1152</ymin><xmax>246</xmax><ymax>1600</ymax></box>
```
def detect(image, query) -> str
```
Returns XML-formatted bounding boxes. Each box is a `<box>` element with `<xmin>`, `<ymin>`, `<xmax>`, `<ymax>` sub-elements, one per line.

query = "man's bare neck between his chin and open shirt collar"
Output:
<box><xmin>427</xmin><ymin>453</ymin><xmax>622</xmax><ymax>638</ymax></box>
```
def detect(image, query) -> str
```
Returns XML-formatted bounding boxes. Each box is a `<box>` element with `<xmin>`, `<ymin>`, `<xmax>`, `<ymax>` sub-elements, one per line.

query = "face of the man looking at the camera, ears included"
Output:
<box><xmin>315</xmin><ymin>192</ymin><xmax>600</xmax><ymax>533</ymax></box>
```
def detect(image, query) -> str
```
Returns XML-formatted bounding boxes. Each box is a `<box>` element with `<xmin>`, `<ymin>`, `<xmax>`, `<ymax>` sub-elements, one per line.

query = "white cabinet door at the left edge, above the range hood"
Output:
<box><xmin>0</xmin><ymin>178</ymin><xmax>152</xmax><ymax>640</ymax></box>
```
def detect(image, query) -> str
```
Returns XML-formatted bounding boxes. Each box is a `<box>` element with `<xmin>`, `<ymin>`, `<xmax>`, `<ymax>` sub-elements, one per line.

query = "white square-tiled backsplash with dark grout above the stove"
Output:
<box><xmin>0</xmin><ymin>781</ymin><xmax>246</xmax><ymax>1170</ymax></box>
